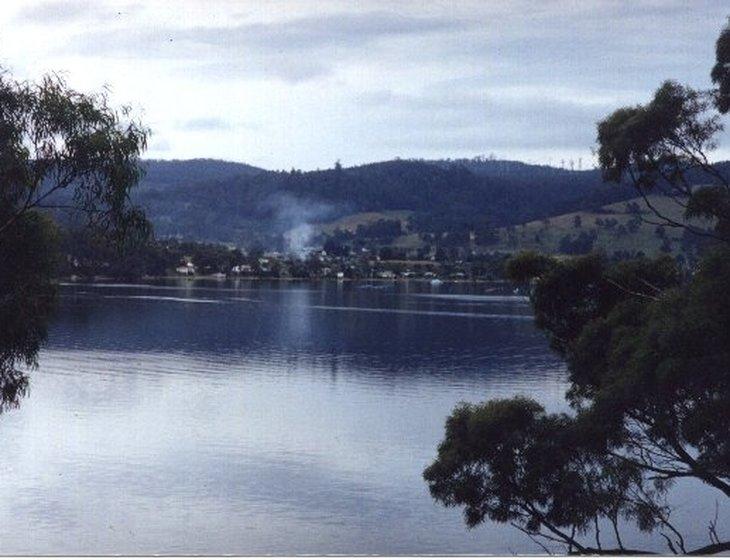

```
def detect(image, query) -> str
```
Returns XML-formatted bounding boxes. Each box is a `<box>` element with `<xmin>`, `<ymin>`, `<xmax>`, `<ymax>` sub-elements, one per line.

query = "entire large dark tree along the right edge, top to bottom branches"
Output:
<box><xmin>424</xmin><ymin>19</ymin><xmax>730</xmax><ymax>554</ymax></box>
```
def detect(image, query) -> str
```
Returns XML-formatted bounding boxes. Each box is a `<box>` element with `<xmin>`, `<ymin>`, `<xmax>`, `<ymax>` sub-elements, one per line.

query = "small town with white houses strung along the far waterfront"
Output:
<box><xmin>62</xmin><ymin>234</ymin><xmax>509</xmax><ymax>281</ymax></box>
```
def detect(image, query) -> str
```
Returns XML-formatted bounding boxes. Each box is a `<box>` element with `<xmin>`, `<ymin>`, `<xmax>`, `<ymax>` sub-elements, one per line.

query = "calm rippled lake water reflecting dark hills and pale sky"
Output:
<box><xmin>0</xmin><ymin>281</ymin><xmax>700</xmax><ymax>555</ymax></box>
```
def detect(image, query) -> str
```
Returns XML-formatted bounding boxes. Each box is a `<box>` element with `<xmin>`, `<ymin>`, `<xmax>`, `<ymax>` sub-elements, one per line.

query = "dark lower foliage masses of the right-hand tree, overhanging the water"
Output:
<box><xmin>424</xmin><ymin>249</ymin><xmax>730</xmax><ymax>553</ymax></box>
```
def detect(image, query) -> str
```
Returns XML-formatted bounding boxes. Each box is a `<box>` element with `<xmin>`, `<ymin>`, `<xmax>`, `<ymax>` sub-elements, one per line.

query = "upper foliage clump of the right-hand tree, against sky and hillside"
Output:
<box><xmin>598</xmin><ymin>81</ymin><xmax>730</xmax><ymax>240</ymax></box>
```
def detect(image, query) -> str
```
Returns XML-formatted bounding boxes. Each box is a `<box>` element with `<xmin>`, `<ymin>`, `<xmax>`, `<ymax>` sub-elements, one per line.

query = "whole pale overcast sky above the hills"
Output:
<box><xmin>0</xmin><ymin>0</ymin><xmax>730</xmax><ymax>169</ymax></box>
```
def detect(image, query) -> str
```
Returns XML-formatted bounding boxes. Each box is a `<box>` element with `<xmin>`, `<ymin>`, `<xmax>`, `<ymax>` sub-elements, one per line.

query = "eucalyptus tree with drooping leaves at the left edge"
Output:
<box><xmin>0</xmin><ymin>71</ymin><xmax>149</xmax><ymax>409</ymax></box>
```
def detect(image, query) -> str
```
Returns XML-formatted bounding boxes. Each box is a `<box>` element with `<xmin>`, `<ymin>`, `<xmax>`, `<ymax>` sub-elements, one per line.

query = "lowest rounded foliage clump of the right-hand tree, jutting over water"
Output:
<box><xmin>424</xmin><ymin>397</ymin><xmax>654</xmax><ymax>552</ymax></box>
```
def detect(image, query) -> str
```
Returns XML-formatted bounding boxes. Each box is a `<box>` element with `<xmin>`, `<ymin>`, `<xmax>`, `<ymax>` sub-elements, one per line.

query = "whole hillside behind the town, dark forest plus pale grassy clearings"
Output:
<box><xmin>47</xmin><ymin>155</ymin><xmax>730</xmax><ymax>254</ymax></box>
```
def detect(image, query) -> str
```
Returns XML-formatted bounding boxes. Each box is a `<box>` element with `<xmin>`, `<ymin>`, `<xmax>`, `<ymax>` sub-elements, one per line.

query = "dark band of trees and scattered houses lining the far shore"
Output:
<box><xmin>56</xmin><ymin>225</ymin><xmax>508</xmax><ymax>280</ymax></box>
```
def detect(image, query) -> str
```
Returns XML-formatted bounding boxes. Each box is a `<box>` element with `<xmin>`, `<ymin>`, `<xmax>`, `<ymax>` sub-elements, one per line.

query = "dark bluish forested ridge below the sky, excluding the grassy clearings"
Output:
<box><xmin>126</xmin><ymin>155</ymin><xmax>716</xmax><ymax>247</ymax></box>
